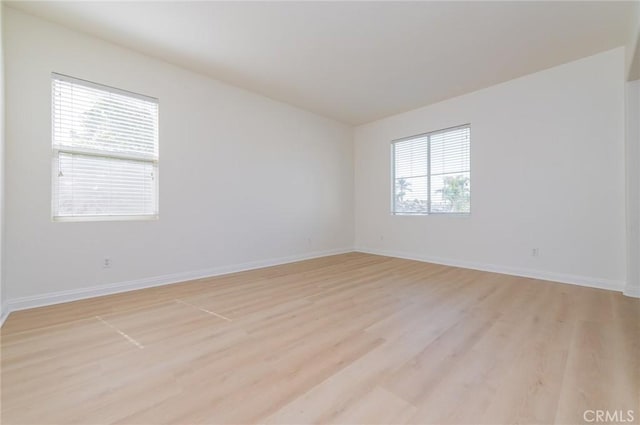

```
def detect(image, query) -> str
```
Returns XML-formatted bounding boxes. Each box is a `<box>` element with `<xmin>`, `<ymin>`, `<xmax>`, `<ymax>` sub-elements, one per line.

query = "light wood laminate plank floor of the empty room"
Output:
<box><xmin>1</xmin><ymin>253</ymin><xmax>640</xmax><ymax>424</ymax></box>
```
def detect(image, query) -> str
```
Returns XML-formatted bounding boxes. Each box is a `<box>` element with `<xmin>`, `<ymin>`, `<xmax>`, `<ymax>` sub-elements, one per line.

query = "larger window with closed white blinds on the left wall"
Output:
<box><xmin>52</xmin><ymin>73</ymin><xmax>158</xmax><ymax>220</ymax></box>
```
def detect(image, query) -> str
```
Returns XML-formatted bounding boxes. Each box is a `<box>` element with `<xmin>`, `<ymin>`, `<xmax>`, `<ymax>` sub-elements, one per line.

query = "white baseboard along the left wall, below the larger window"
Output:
<box><xmin>2</xmin><ymin>248</ymin><xmax>353</xmax><ymax>314</ymax></box>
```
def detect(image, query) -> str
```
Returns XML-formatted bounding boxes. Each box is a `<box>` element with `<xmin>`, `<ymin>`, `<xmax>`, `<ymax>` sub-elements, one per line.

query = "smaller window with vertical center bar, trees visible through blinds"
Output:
<box><xmin>391</xmin><ymin>124</ymin><xmax>471</xmax><ymax>215</ymax></box>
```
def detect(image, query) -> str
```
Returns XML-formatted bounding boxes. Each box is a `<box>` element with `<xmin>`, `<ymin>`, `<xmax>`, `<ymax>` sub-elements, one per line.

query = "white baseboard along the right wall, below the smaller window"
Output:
<box><xmin>355</xmin><ymin>247</ymin><xmax>626</xmax><ymax>295</ymax></box>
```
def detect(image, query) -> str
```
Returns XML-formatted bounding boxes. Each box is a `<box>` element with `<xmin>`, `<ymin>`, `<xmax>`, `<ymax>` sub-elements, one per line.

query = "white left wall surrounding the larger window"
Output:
<box><xmin>5</xmin><ymin>8</ymin><xmax>353</xmax><ymax>308</ymax></box>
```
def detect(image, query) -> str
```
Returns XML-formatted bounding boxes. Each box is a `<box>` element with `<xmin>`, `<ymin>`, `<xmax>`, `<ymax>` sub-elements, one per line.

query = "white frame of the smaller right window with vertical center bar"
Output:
<box><xmin>390</xmin><ymin>123</ymin><xmax>472</xmax><ymax>217</ymax></box>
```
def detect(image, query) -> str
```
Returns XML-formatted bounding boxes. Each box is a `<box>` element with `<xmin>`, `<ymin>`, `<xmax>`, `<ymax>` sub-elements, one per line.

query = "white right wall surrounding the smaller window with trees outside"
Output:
<box><xmin>355</xmin><ymin>48</ymin><xmax>626</xmax><ymax>290</ymax></box>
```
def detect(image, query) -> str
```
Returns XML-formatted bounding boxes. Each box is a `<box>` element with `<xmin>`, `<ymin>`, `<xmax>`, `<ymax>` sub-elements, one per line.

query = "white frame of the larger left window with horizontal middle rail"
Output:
<box><xmin>50</xmin><ymin>72</ymin><xmax>160</xmax><ymax>222</ymax></box>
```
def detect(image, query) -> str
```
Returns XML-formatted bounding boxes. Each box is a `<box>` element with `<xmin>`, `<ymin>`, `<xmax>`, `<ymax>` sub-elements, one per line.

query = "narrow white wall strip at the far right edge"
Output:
<box><xmin>624</xmin><ymin>80</ymin><xmax>640</xmax><ymax>297</ymax></box>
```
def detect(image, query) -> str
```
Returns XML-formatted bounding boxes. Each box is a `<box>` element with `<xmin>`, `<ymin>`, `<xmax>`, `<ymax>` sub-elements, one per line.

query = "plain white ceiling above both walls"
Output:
<box><xmin>9</xmin><ymin>1</ymin><xmax>635</xmax><ymax>124</ymax></box>
